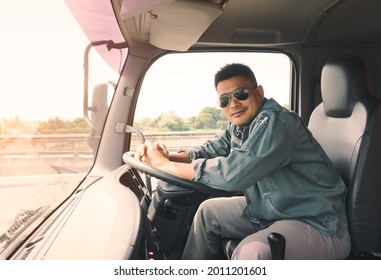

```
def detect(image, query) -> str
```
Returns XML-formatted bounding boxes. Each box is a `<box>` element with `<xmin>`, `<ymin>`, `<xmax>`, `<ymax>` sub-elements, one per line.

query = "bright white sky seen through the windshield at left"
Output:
<box><xmin>0</xmin><ymin>0</ymin><xmax>111</xmax><ymax>120</ymax></box>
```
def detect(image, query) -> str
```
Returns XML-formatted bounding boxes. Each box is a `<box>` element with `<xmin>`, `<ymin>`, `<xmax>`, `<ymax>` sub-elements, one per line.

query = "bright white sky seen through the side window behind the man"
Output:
<box><xmin>136</xmin><ymin>53</ymin><xmax>290</xmax><ymax>119</ymax></box>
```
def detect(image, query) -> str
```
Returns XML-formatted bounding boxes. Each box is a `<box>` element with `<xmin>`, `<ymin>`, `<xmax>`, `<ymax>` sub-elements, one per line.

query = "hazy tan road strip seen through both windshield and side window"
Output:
<box><xmin>0</xmin><ymin>132</ymin><xmax>215</xmax><ymax>177</ymax></box>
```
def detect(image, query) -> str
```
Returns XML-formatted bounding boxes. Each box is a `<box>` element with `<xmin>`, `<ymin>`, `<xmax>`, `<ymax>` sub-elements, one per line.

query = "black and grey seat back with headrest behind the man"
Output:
<box><xmin>308</xmin><ymin>56</ymin><xmax>381</xmax><ymax>258</ymax></box>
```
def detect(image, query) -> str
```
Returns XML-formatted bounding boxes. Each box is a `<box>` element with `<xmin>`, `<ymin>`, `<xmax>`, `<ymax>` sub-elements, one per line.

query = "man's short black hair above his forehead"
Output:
<box><xmin>214</xmin><ymin>63</ymin><xmax>258</xmax><ymax>88</ymax></box>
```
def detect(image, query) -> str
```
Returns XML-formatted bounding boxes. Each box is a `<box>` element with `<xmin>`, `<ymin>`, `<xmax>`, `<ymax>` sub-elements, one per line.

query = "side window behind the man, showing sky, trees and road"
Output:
<box><xmin>131</xmin><ymin>52</ymin><xmax>291</xmax><ymax>150</ymax></box>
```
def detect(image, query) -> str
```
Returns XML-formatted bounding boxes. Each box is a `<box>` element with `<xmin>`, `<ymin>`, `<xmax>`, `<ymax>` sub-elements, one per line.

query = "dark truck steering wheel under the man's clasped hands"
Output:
<box><xmin>123</xmin><ymin>128</ymin><xmax>232</xmax><ymax>196</ymax></box>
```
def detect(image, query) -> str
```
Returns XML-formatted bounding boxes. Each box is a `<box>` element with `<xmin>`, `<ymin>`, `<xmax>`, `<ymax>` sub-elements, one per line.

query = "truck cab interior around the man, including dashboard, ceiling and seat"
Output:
<box><xmin>4</xmin><ymin>0</ymin><xmax>381</xmax><ymax>260</ymax></box>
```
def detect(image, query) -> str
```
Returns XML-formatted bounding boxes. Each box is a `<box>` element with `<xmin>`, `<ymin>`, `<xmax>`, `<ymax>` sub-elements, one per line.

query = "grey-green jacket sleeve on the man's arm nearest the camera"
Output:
<box><xmin>192</xmin><ymin>113</ymin><xmax>292</xmax><ymax>191</ymax></box>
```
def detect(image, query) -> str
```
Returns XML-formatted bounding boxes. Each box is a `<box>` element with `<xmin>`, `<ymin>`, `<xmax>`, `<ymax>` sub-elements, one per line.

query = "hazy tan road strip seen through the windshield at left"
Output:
<box><xmin>0</xmin><ymin>136</ymin><xmax>93</xmax><ymax>176</ymax></box>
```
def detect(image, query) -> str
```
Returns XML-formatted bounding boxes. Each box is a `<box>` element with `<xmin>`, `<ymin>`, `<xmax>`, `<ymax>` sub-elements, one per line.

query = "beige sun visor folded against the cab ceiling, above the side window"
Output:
<box><xmin>121</xmin><ymin>0</ymin><xmax>227</xmax><ymax>51</ymax></box>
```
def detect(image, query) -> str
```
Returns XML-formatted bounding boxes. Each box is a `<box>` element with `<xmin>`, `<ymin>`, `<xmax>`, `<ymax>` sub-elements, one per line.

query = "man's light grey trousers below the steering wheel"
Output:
<box><xmin>182</xmin><ymin>197</ymin><xmax>351</xmax><ymax>260</ymax></box>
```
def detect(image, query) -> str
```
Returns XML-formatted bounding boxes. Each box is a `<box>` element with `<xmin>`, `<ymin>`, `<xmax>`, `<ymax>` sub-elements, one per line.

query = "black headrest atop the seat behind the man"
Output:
<box><xmin>321</xmin><ymin>56</ymin><xmax>371</xmax><ymax>118</ymax></box>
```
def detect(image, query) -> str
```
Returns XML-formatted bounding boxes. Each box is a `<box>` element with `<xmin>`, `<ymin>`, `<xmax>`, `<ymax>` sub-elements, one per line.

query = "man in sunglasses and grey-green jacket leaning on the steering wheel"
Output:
<box><xmin>136</xmin><ymin>64</ymin><xmax>350</xmax><ymax>259</ymax></box>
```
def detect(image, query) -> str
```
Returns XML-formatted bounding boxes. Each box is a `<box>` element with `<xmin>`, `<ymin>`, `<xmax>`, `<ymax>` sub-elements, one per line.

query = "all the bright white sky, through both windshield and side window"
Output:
<box><xmin>0</xmin><ymin>0</ymin><xmax>289</xmax><ymax>121</ymax></box>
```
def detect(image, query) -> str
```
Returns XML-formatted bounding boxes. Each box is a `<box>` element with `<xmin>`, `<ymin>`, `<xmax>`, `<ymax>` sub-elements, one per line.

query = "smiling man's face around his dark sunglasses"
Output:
<box><xmin>216</xmin><ymin>76</ymin><xmax>264</xmax><ymax>126</ymax></box>
